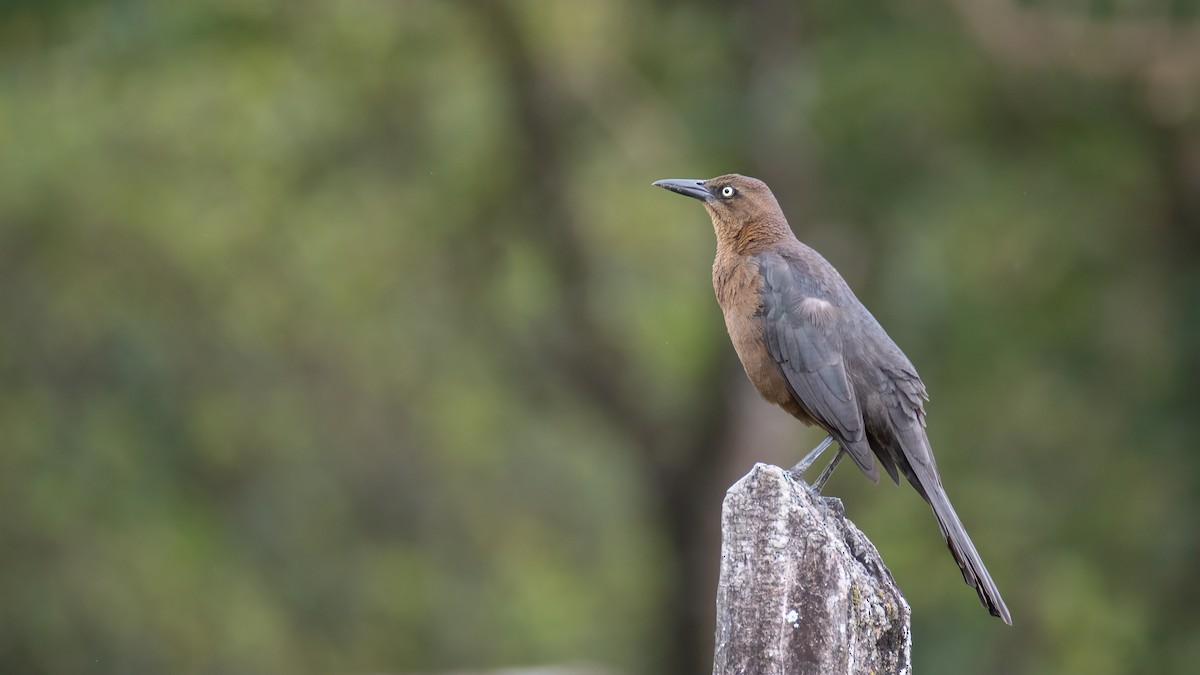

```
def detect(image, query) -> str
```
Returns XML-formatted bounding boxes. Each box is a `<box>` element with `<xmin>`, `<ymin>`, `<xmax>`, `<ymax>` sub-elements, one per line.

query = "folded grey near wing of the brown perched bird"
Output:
<box><xmin>758</xmin><ymin>253</ymin><xmax>878</xmax><ymax>480</ymax></box>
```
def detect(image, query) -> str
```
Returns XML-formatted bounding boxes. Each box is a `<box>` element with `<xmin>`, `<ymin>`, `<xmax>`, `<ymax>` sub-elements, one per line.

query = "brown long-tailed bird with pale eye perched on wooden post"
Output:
<box><xmin>653</xmin><ymin>173</ymin><xmax>1013</xmax><ymax>625</ymax></box>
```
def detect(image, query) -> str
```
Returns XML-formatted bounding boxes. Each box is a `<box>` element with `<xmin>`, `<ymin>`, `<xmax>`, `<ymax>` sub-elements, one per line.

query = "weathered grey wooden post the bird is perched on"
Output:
<box><xmin>713</xmin><ymin>464</ymin><xmax>912</xmax><ymax>675</ymax></box>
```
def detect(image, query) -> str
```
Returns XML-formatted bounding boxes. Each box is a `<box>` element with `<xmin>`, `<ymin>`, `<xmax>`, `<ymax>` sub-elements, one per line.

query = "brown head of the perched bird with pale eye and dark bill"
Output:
<box><xmin>654</xmin><ymin>173</ymin><xmax>792</xmax><ymax>249</ymax></box>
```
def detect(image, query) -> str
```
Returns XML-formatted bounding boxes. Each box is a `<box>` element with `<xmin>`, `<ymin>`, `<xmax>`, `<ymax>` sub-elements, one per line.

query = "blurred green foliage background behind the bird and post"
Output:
<box><xmin>0</xmin><ymin>0</ymin><xmax>1200</xmax><ymax>675</ymax></box>
